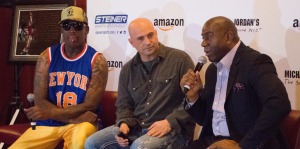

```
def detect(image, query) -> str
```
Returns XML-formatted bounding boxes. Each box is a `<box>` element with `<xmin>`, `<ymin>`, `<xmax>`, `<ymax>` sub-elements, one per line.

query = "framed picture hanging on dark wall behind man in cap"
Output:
<box><xmin>9</xmin><ymin>4</ymin><xmax>67</xmax><ymax>61</ymax></box>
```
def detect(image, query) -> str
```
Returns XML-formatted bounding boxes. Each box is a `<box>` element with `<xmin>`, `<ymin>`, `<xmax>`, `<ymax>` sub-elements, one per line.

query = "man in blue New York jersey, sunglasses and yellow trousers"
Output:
<box><xmin>10</xmin><ymin>6</ymin><xmax>108</xmax><ymax>149</ymax></box>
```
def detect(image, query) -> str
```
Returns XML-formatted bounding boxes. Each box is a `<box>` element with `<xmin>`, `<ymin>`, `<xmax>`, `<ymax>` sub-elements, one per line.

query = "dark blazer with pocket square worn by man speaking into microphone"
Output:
<box><xmin>187</xmin><ymin>42</ymin><xmax>291</xmax><ymax>149</ymax></box>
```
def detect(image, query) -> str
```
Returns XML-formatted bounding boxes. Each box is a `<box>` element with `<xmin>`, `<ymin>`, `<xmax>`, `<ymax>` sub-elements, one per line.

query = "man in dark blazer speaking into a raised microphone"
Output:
<box><xmin>180</xmin><ymin>16</ymin><xmax>291</xmax><ymax>149</ymax></box>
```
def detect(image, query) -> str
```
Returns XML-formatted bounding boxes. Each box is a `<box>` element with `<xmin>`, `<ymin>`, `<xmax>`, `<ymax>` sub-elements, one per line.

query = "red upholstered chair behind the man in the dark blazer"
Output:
<box><xmin>282</xmin><ymin>110</ymin><xmax>300</xmax><ymax>149</ymax></box>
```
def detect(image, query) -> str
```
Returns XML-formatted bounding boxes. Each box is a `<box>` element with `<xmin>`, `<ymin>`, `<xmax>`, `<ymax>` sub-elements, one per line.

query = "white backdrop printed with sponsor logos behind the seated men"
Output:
<box><xmin>87</xmin><ymin>0</ymin><xmax>300</xmax><ymax>110</ymax></box>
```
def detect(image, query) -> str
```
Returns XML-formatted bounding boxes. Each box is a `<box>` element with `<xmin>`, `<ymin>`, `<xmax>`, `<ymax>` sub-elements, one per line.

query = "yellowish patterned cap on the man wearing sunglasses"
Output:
<box><xmin>58</xmin><ymin>6</ymin><xmax>88</xmax><ymax>24</ymax></box>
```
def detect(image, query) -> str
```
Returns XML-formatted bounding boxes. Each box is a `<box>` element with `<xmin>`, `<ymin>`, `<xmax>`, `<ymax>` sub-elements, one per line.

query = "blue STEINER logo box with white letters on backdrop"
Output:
<box><xmin>95</xmin><ymin>15</ymin><xmax>128</xmax><ymax>24</ymax></box>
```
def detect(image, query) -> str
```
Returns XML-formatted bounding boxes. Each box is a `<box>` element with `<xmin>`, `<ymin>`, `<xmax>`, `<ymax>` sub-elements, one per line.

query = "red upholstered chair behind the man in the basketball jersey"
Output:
<box><xmin>0</xmin><ymin>91</ymin><xmax>118</xmax><ymax>149</ymax></box>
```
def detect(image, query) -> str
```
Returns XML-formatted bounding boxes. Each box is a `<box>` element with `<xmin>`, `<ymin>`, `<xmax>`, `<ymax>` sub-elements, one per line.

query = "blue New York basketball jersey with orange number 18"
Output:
<box><xmin>37</xmin><ymin>43</ymin><xmax>100</xmax><ymax>126</ymax></box>
